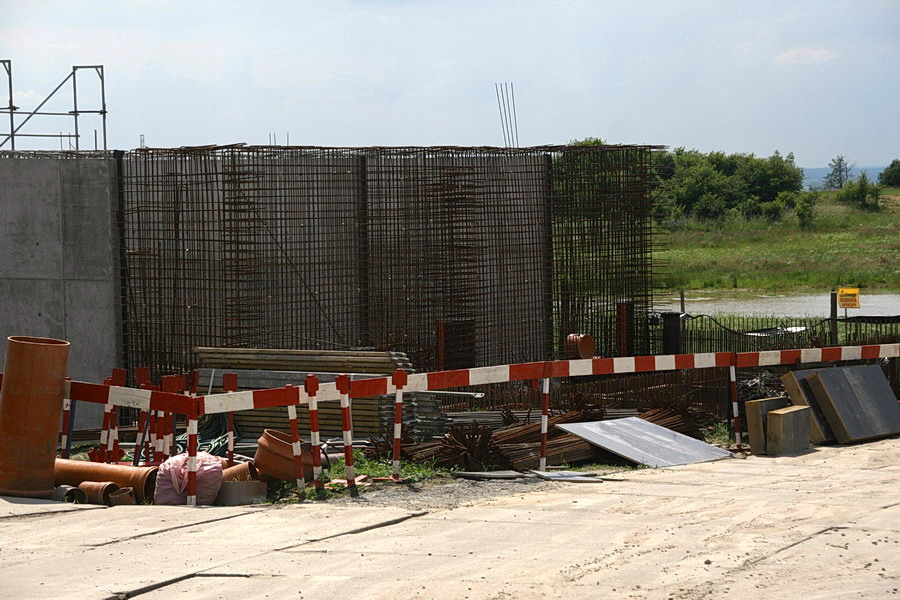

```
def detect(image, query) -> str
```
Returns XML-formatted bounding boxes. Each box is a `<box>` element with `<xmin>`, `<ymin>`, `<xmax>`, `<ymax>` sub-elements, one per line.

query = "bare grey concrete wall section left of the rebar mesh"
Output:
<box><xmin>0</xmin><ymin>153</ymin><xmax>120</xmax><ymax>428</ymax></box>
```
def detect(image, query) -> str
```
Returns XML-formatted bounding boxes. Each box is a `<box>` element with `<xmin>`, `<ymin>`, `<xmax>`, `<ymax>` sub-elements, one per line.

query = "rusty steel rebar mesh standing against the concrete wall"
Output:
<box><xmin>120</xmin><ymin>146</ymin><xmax>654</xmax><ymax>373</ymax></box>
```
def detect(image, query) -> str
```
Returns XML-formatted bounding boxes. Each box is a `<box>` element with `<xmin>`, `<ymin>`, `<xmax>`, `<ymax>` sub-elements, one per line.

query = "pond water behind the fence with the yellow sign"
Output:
<box><xmin>653</xmin><ymin>290</ymin><xmax>900</xmax><ymax>317</ymax></box>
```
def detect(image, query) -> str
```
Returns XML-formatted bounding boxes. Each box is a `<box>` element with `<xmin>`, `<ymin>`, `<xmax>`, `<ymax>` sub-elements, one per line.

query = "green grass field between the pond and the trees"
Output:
<box><xmin>654</xmin><ymin>188</ymin><xmax>900</xmax><ymax>291</ymax></box>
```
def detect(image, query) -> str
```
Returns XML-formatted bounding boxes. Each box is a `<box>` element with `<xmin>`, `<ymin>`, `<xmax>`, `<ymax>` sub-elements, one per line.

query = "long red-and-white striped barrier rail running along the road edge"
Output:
<box><xmin>59</xmin><ymin>344</ymin><xmax>900</xmax><ymax>504</ymax></box>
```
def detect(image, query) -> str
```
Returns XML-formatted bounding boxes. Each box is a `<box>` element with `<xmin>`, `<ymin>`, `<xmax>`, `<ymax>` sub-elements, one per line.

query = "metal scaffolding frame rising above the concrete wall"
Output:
<box><xmin>0</xmin><ymin>59</ymin><xmax>107</xmax><ymax>151</ymax></box>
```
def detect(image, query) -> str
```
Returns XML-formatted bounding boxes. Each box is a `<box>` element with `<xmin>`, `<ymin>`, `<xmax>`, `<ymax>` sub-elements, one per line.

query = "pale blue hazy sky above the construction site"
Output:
<box><xmin>0</xmin><ymin>0</ymin><xmax>900</xmax><ymax>167</ymax></box>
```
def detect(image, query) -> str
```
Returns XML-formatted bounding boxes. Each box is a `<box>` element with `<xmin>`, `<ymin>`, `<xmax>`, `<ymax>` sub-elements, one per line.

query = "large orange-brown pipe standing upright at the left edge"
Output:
<box><xmin>0</xmin><ymin>336</ymin><xmax>69</xmax><ymax>498</ymax></box>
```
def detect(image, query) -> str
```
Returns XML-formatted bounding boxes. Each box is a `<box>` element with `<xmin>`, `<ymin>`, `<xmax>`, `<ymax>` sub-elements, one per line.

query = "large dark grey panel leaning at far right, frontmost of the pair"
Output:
<box><xmin>805</xmin><ymin>365</ymin><xmax>900</xmax><ymax>444</ymax></box>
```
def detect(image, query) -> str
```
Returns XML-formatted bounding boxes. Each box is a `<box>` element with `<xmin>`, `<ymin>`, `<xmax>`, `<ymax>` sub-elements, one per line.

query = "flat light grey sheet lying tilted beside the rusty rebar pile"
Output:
<box><xmin>557</xmin><ymin>417</ymin><xmax>731</xmax><ymax>468</ymax></box>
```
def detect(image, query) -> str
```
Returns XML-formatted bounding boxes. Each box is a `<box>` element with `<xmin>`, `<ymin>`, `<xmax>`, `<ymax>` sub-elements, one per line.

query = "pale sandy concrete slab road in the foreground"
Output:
<box><xmin>0</xmin><ymin>438</ymin><xmax>900</xmax><ymax>600</ymax></box>
